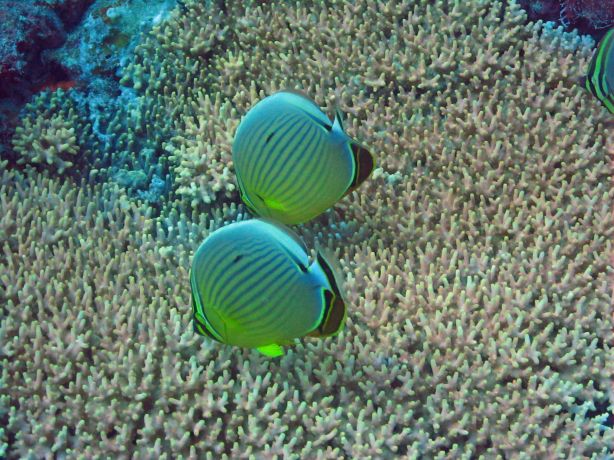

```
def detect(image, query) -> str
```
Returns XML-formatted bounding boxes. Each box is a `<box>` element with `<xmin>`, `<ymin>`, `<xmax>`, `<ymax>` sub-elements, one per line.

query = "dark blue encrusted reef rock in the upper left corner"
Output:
<box><xmin>0</xmin><ymin>0</ymin><xmax>176</xmax><ymax>162</ymax></box>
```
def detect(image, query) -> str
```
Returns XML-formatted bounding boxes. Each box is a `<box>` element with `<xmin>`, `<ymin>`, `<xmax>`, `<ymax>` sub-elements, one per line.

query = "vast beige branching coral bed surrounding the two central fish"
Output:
<box><xmin>0</xmin><ymin>0</ymin><xmax>614</xmax><ymax>459</ymax></box>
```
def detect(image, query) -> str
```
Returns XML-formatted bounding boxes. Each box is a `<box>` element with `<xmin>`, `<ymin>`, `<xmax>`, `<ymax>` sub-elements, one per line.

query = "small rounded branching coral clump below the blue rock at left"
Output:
<box><xmin>13</xmin><ymin>90</ymin><xmax>96</xmax><ymax>174</ymax></box>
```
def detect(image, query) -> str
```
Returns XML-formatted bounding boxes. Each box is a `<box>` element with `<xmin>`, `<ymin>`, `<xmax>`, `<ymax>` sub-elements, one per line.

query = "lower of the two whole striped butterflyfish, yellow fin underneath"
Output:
<box><xmin>190</xmin><ymin>219</ymin><xmax>345</xmax><ymax>355</ymax></box>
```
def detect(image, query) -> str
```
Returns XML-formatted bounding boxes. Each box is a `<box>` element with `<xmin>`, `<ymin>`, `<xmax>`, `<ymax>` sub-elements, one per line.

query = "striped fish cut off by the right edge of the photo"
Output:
<box><xmin>585</xmin><ymin>28</ymin><xmax>614</xmax><ymax>113</ymax></box>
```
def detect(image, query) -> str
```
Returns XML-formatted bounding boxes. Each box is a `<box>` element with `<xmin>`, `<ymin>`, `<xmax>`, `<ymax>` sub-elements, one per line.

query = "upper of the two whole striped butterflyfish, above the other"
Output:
<box><xmin>232</xmin><ymin>91</ymin><xmax>374</xmax><ymax>224</ymax></box>
